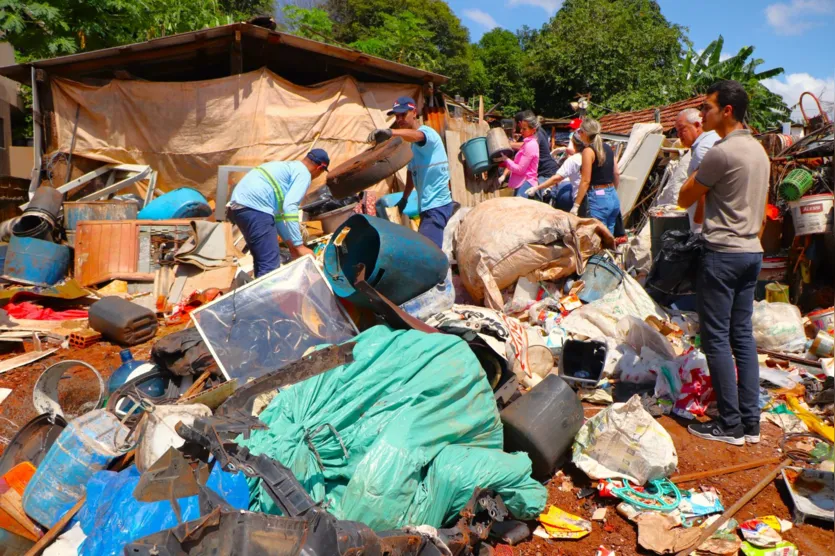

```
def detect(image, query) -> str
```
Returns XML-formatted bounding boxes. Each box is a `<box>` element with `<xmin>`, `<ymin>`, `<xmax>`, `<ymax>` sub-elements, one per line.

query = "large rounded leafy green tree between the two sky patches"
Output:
<box><xmin>529</xmin><ymin>0</ymin><xmax>687</xmax><ymax>115</ymax></box>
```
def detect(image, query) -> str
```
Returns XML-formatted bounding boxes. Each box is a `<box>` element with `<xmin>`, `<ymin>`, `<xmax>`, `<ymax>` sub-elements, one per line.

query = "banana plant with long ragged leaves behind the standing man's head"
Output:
<box><xmin>679</xmin><ymin>35</ymin><xmax>791</xmax><ymax>131</ymax></box>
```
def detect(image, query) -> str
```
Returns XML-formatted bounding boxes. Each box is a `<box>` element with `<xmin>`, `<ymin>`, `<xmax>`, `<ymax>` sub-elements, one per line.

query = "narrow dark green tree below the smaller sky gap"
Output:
<box><xmin>470</xmin><ymin>28</ymin><xmax>534</xmax><ymax>115</ymax></box>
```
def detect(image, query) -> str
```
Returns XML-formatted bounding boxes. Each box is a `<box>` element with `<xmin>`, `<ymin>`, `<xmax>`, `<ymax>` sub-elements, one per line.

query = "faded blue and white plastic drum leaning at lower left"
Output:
<box><xmin>23</xmin><ymin>409</ymin><xmax>130</xmax><ymax>527</ymax></box>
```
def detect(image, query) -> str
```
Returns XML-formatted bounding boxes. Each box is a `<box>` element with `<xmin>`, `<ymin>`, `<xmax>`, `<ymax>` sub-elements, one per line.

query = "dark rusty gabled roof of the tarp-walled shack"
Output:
<box><xmin>0</xmin><ymin>23</ymin><xmax>449</xmax><ymax>84</ymax></box>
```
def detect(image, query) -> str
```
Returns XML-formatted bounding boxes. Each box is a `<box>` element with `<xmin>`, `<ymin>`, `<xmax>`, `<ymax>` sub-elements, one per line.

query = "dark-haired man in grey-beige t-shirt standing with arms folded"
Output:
<box><xmin>678</xmin><ymin>81</ymin><xmax>771</xmax><ymax>446</ymax></box>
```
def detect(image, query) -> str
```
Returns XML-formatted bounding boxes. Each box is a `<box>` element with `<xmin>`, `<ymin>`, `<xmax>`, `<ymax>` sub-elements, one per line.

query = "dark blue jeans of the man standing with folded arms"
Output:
<box><xmin>698</xmin><ymin>248</ymin><xmax>762</xmax><ymax>429</ymax></box>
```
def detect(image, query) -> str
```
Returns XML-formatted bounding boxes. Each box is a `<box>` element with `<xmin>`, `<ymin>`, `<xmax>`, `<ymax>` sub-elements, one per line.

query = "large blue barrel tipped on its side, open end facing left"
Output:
<box><xmin>324</xmin><ymin>214</ymin><xmax>449</xmax><ymax>306</ymax></box>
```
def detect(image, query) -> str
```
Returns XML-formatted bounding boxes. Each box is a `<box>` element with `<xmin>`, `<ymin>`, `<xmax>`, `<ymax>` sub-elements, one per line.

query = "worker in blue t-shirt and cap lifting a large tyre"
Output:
<box><xmin>368</xmin><ymin>97</ymin><xmax>452</xmax><ymax>249</ymax></box>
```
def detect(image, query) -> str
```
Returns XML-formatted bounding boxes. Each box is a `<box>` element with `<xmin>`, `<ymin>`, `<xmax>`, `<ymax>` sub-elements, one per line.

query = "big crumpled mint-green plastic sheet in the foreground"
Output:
<box><xmin>238</xmin><ymin>326</ymin><xmax>547</xmax><ymax>530</ymax></box>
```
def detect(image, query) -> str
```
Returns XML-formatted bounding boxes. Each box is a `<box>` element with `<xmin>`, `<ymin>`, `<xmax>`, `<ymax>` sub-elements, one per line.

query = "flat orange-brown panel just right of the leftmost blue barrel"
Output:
<box><xmin>75</xmin><ymin>220</ymin><xmax>140</xmax><ymax>287</ymax></box>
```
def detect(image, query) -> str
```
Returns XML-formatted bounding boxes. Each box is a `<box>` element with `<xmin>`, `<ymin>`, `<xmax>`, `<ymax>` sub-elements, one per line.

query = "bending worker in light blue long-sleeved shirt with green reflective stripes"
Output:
<box><xmin>227</xmin><ymin>149</ymin><xmax>330</xmax><ymax>278</ymax></box>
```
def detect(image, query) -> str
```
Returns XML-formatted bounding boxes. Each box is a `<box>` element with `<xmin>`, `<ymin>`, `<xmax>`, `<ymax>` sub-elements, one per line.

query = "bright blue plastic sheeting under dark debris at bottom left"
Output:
<box><xmin>78</xmin><ymin>465</ymin><xmax>249</xmax><ymax>556</ymax></box>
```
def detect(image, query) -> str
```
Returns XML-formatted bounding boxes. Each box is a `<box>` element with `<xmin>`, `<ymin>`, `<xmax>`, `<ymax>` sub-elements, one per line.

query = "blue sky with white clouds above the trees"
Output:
<box><xmin>448</xmin><ymin>0</ymin><xmax>835</xmax><ymax>117</ymax></box>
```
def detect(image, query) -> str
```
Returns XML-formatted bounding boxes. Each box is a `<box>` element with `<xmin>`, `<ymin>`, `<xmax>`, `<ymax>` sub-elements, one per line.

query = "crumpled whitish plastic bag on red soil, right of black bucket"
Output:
<box><xmin>572</xmin><ymin>395</ymin><xmax>678</xmax><ymax>485</ymax></box>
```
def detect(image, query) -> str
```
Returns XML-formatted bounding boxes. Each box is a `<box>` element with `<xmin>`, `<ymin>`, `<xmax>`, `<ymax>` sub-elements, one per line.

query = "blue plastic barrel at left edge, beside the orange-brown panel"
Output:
<box><xmin>3</xmin><ymin>235</ymin><xmax>70</xmax><ymax>286</ymax></box>
